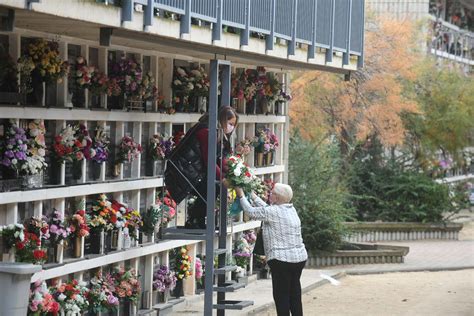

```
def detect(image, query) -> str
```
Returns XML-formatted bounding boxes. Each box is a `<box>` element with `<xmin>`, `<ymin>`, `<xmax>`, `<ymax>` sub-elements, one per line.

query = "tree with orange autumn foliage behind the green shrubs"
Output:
<box><xmin>290</xmin><ymin>20</ymin><xmax>418</xmax><ymax>157</ymax></box>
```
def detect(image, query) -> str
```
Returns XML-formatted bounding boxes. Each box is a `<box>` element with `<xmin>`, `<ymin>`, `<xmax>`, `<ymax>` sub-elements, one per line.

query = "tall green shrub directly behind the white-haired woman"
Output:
<box><xmin>288</xmin><ymin>134</ymin><xmax>352</xmax><ymax>251</ymax></box>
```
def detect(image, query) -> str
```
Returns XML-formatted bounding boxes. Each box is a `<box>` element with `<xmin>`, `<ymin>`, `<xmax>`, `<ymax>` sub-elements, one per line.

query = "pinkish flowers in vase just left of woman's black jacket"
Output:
<box><xmin>145</xmin><ymin>134</ymin><xmax>174</xmax><ymax>177</ymax></box>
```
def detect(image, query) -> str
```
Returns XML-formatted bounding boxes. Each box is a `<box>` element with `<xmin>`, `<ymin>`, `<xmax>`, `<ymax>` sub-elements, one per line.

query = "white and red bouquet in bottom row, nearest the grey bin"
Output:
<box><xmin>28</xmin><ymin>280</ymin><xmax>59</xmax><ymax>316</ymax></box>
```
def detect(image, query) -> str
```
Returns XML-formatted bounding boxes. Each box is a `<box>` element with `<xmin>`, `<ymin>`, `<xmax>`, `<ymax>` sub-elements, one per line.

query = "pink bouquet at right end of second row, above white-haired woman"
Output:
<box><xmin>253</xmin><ymin>128</ymin><xmax>279</xmax><ymax>167</ymax></box>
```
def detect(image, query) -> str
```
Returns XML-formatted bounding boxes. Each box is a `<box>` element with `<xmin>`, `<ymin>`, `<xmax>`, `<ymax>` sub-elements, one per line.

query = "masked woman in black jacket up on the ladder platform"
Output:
<box><xmin>165</xmin><ymin>106</ymin><xmax>238</xmax><ymax>229</ymax></box>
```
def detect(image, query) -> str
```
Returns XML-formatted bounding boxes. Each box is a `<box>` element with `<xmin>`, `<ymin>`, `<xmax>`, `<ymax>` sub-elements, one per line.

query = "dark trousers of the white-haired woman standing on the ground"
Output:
<box><xmin>268</xmin><ymin>259</ymin><xmax>306</xmax><ymax>316</ymax></box>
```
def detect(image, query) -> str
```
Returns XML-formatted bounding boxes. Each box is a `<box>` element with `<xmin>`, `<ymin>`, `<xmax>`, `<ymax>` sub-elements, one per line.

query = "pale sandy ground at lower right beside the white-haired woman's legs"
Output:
<box><xmin>262</xmin><ymin>212</ymin><xmax>474</xmax><ymax>316</ymax></box>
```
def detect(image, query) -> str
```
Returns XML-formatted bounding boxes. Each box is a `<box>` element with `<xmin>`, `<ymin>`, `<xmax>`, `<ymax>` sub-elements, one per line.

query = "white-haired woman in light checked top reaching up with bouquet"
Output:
<box><xmin>236</xmin><ymin>183</ymin><xmax>308</xmax><ymax>316</ymax></box>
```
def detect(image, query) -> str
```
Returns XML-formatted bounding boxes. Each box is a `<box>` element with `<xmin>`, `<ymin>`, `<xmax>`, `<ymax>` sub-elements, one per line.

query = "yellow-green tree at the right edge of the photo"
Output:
<box><xmin>404</xmin><ymin>60</ymin><xmax>474</xmax><ymax>169</ymax></box>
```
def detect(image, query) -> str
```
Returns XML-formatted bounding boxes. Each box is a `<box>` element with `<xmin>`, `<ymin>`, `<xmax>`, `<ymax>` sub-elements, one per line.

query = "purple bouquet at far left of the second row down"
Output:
<box><xmin>0</xmin><ymin>121</ymin><xmax>28</xmax><ymax>175</ymax></box>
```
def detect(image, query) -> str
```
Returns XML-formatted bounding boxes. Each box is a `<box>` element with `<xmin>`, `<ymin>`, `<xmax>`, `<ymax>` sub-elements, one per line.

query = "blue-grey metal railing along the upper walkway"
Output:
<box><xmin>112</xmin><ymin>0</ymin><xmax>365</xmax><ymax>67</ymax></box>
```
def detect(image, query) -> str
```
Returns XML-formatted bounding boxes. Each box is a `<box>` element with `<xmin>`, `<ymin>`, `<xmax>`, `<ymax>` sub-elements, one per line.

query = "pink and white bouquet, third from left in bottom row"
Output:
<box><xmin>87</xmin><ymin>271</ymin><xmax>120</xmax><ymax>313</ymax></box>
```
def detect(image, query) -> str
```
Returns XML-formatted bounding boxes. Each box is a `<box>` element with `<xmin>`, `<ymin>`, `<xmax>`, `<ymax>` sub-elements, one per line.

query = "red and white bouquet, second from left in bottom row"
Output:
<box><xmin>52</xmin><ymin>279</ymin><xmax>89</xmax><ymax>315</ymax></box>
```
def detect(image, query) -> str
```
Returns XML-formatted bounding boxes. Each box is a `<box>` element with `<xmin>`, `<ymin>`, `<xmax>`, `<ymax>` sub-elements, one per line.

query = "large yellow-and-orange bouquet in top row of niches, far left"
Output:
<box><xmin>18</xmin><ymin>39</ymin><xmax>69</xmax><ymax>106</ymax></box>
